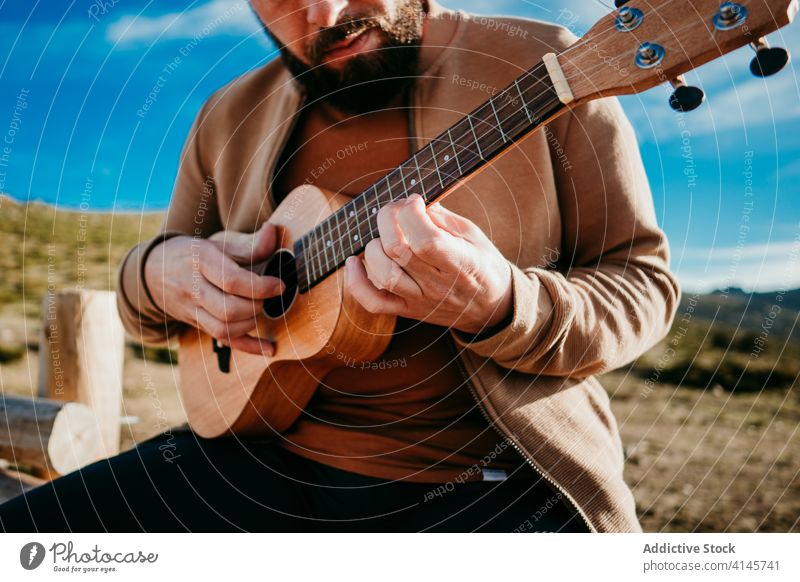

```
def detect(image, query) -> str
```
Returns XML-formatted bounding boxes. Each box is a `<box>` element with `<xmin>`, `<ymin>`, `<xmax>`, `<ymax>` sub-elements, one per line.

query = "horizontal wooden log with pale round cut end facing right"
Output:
<box><xmin>0</xmin><ymin>395</ymin><xmax>105</xmax><ymax>476</ymax></box>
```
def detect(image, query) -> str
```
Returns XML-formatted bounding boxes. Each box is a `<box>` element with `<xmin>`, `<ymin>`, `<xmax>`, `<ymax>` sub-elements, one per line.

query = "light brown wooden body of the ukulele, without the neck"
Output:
<box><xmin>178</xmin><ymin>185</ymin><xmax>397</xmax><ymax>438</ymax></box>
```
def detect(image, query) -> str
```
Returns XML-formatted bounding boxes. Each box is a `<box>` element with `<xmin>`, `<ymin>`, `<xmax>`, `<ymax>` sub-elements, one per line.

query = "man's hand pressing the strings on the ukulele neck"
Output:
<box><xmin>345</xmin><ymin>194</ymin><xmax>513</xmax><ymax>334</ymax></box>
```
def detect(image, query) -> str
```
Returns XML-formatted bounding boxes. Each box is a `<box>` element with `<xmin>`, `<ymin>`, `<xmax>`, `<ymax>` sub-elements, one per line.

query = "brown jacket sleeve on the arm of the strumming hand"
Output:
<box><xmin>117</xmin><ymin>100</ymin><xmax>222</xmax><ymax>345</ymax></box>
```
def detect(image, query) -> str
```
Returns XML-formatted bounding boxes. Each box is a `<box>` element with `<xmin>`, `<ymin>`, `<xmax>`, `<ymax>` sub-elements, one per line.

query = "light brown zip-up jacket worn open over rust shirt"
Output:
<box><xmin>118</xmin><ymin>2</ymin><xmax>680</xmax><ymax>532</ymax></box>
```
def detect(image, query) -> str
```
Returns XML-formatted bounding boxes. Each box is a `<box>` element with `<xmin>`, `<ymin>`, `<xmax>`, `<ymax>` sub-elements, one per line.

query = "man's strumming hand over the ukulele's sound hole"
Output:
<box><xmin>144</xmin><ymin>222</ymin><xmax>285</xmax><ymax>356</ymax></box>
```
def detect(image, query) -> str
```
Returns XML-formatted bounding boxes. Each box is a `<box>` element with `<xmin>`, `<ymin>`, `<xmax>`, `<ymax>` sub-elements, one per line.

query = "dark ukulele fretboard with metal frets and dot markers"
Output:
<box><xmin>294</xmin><ymin>64</ymin><xmax>563</xmax><ymax>293</ymax></box>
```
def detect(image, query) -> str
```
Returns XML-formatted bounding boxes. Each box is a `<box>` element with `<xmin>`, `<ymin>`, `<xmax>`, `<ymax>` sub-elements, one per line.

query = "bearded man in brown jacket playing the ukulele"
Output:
<box><xmin>0</xmin><ymin>0</ymin><xmax>679</xmax><ymax>531</ymax></box>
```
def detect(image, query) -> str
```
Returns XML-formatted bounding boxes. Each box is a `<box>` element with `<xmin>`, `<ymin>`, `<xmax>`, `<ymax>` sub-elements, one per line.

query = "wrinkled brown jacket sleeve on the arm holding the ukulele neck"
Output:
<box><xmin>450</xmin><ymin>98</ymin><xmax>680</xmax><ymax>377</ymax></box>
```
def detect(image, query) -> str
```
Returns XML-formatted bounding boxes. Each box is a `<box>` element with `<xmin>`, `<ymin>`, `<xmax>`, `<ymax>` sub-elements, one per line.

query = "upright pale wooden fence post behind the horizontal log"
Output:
<box><xmin>39</xmin><ymin>289</ymin><xmax>125</xmax><ymax>457</ymax></box>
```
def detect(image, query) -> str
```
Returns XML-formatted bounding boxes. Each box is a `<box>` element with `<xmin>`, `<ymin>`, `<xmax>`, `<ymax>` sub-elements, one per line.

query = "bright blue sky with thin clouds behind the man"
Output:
<box><xmin>0</xmin><ymin>0</ymin><xmax>800</xmax><ymax>290</ymax></box>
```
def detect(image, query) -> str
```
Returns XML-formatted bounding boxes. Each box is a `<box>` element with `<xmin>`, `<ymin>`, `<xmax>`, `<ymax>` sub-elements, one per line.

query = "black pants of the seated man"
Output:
<box><xmin>0</xmin><ymin>430</ymin><xmax>586</xmax><ymax>532</ymax></box>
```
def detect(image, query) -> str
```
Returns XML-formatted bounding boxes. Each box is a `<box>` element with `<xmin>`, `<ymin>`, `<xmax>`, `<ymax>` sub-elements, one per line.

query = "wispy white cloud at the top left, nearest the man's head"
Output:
<box><xmin>106</xmin><ymin>0</ymin><xmax>261</xmax><ymax>45</ymax></box>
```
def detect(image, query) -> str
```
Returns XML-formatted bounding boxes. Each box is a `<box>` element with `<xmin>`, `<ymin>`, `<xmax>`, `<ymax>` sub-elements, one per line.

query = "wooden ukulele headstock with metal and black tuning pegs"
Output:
<box><xmin>558</xmin><ymin>0</ymin><xmax>798</xmax><ymax>111</ymax></box>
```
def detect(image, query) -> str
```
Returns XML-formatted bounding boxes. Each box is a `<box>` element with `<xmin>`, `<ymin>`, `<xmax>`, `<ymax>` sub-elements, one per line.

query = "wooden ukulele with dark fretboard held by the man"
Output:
<box><xmin>178</xmin><ymin>0</ymin><xmax>798</xmax><ymax>438</ymax></box>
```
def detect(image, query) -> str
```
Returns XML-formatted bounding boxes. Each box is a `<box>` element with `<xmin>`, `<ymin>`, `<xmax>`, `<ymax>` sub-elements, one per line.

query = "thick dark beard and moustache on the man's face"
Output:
<box><xmin>265</xmin><ymin>0</ymin><xmax>425</xmax><ymax>115</ymax></box>
